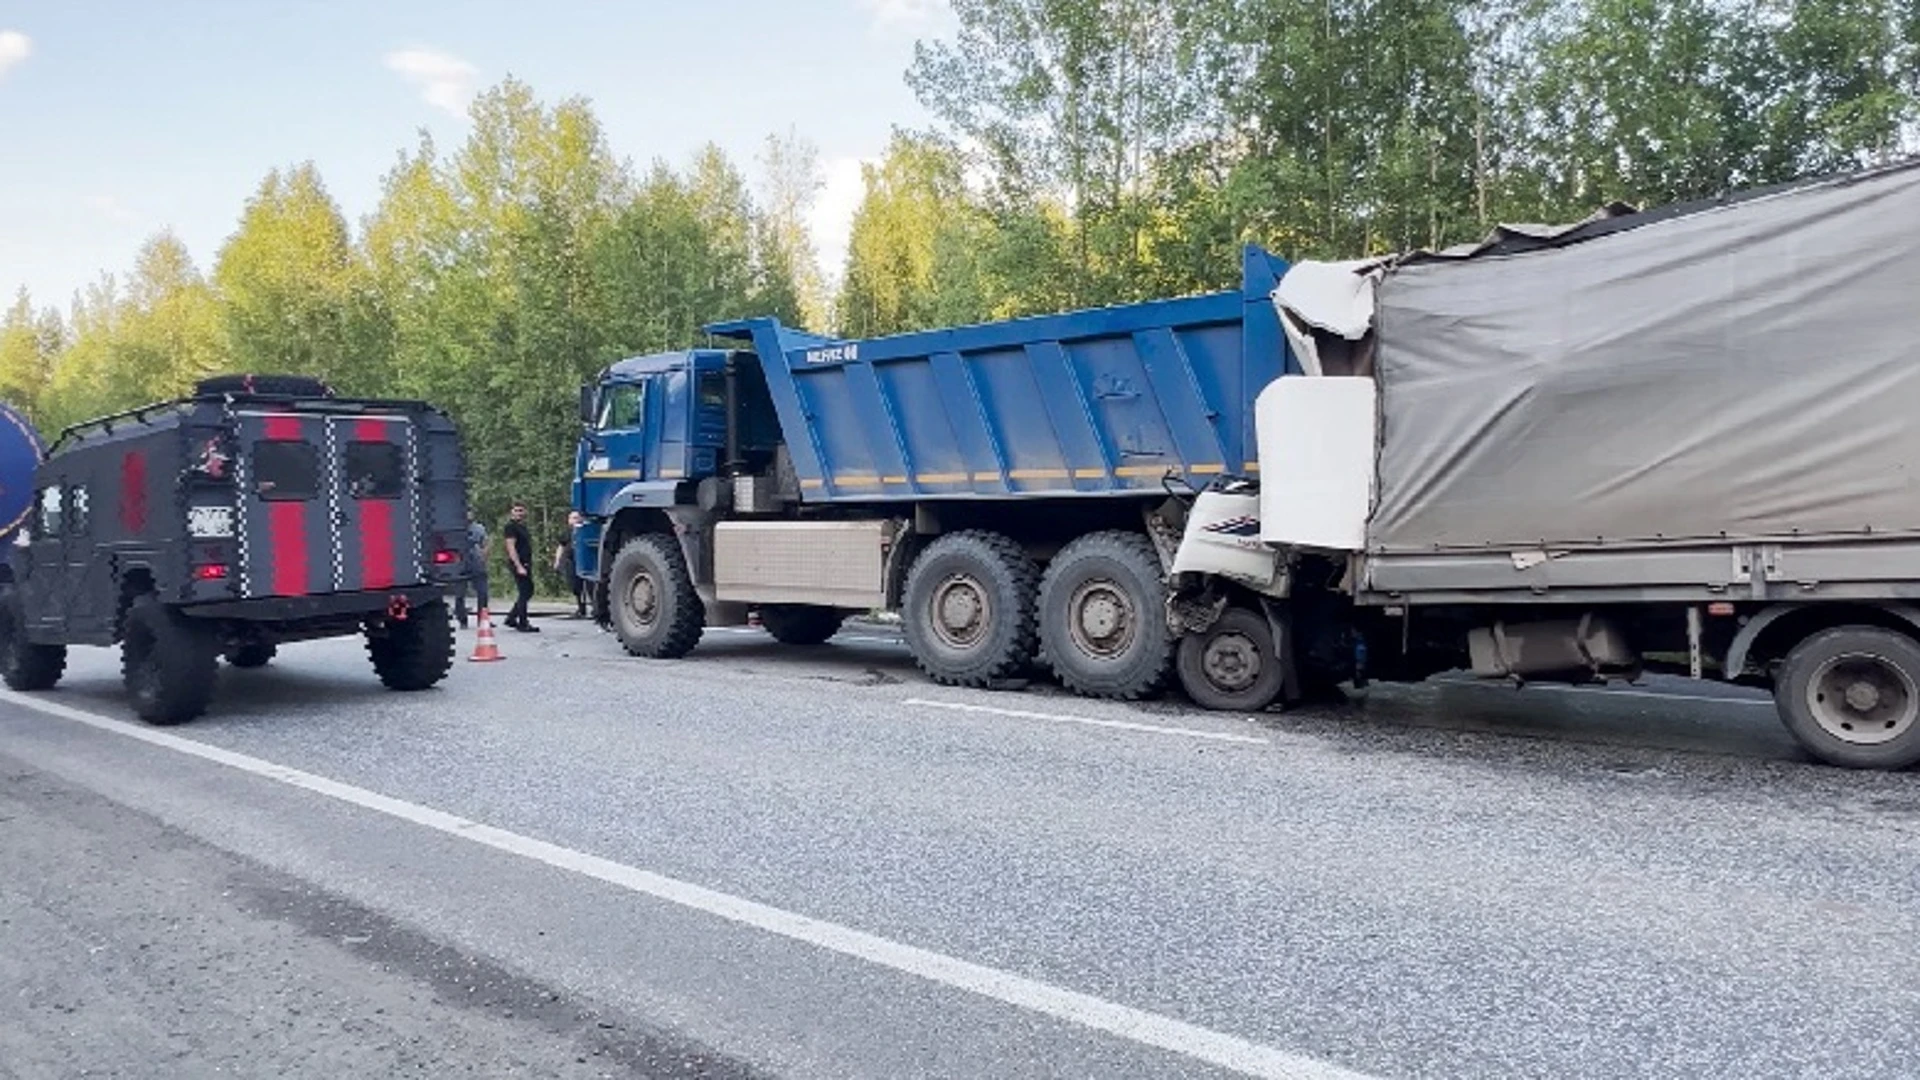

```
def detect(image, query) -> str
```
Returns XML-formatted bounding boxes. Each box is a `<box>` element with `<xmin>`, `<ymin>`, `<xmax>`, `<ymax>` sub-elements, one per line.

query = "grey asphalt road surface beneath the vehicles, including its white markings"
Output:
<box><xmin>0</xmin><ymin>621</ymin><xmax>1920</xmax><ymax>1078</ymax></box>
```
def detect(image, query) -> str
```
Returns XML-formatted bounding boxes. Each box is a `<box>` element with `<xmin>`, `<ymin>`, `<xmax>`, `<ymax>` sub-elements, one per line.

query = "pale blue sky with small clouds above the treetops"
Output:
<box><xmin>0</xmin><ymin>0</ymin><xmax>950</xmax><ymax>307</ymax></box>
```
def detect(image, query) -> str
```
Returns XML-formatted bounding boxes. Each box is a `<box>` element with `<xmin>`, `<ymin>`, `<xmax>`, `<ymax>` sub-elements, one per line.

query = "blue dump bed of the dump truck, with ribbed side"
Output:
<box><xmin>707</xmin><ymin>246</ymin><xmax>1292</xmax><ymax>502</ymax></box>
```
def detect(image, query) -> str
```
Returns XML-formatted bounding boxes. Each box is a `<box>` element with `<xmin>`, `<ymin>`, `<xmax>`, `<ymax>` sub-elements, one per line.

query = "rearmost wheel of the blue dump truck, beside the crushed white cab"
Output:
<box><xmin>1039</xmin><ymin>532</ymin><xmax>1173</xmax><ymax>701</ymax></box>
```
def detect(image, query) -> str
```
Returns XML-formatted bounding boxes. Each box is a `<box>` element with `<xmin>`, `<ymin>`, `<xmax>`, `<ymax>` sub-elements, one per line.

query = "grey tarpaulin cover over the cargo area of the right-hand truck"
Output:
<box><xmin>1369</xmin><ymin>165</ymin><xmax>1920</xmax><ymax>552</ymax></box>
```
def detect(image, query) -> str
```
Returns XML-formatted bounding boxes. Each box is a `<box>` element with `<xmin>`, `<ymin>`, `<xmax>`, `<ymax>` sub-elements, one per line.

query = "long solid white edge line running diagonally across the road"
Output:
<box><xmin>0</xmin><ymin>690</ymin><xmax>1373</xmax><ymax>1080</ymax></box>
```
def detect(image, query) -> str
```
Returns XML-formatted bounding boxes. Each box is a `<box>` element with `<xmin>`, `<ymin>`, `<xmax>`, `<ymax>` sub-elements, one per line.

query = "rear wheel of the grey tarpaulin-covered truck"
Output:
<box><xmin>1774</xmin><ymin>626</ymin><xmax>1920</xmax><ymax>769</ymax></box>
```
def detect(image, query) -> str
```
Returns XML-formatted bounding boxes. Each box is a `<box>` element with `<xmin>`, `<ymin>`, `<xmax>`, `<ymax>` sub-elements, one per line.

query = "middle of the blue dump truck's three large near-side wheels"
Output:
<box><xmin>900</xmin><ymin>530</ymin><xmax>1041</xmax><ymax>686</ymax></box>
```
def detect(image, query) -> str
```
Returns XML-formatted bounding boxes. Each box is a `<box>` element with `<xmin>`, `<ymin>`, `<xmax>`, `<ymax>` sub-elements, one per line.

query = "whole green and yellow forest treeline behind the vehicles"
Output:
<box><xmin>0</xmin><ymin>0</ymin><xmax>1920</xmax><ymax>534</ymax></box>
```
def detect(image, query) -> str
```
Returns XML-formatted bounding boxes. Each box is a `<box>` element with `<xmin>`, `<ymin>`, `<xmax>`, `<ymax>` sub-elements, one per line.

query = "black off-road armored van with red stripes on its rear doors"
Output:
<box><xmin>0</xmin><ymin>375</ymin><xmax>467</xmax><ymax>724</ymax></box>
